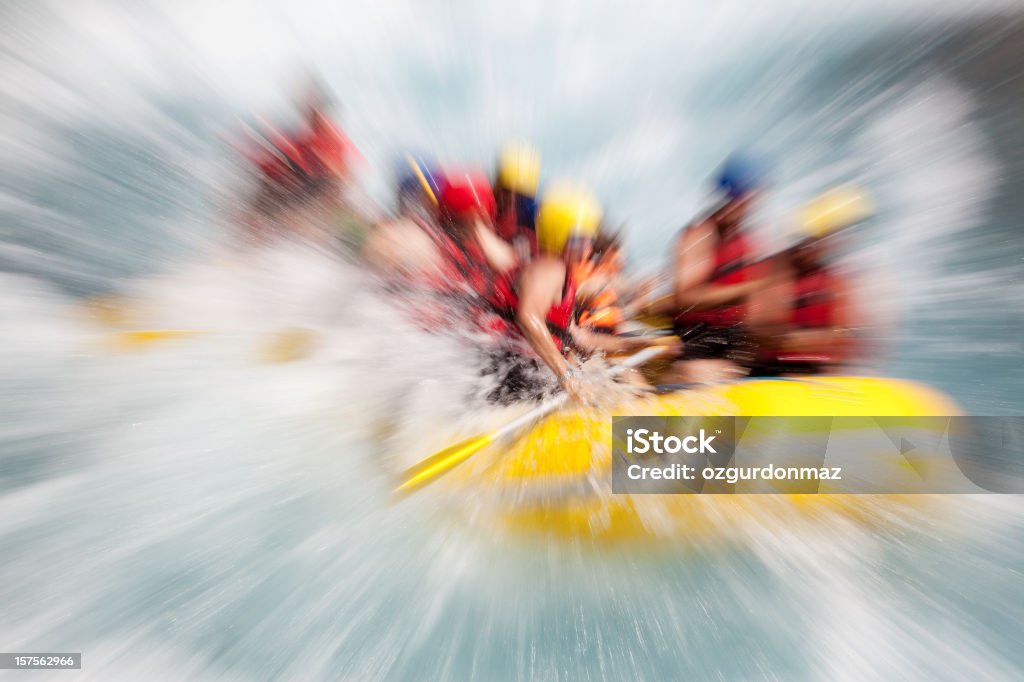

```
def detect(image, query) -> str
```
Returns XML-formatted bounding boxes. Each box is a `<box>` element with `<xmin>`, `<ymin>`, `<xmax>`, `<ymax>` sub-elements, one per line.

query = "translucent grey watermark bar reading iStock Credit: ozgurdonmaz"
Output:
<box><xmin>611</xmin><ymin>416</ymin><xmax>1024</xmax><ymax>495</ymax></box>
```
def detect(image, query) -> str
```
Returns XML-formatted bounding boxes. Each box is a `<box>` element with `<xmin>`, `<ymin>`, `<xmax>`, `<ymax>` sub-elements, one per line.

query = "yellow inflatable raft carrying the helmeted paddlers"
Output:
<box><xmin>445</xmin><ymin>377</ymin><xmax>961</xmax><ymax>542</ymax></box>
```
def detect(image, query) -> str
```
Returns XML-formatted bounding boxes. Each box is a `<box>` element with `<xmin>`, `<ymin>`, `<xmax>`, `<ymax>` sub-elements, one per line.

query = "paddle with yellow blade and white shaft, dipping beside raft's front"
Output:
<box><xmin>394</xmin><ymin>346</ymin><xmax>667</xmax><ymax>494</ymax></box>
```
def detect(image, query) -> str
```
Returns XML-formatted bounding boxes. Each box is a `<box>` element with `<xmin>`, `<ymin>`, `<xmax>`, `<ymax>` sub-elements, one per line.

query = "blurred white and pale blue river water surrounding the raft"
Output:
<box><xmin>0</xmin><ymin>1</ymin><xmax>1024</xmax><ymax>680</ymax></box>
